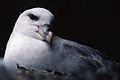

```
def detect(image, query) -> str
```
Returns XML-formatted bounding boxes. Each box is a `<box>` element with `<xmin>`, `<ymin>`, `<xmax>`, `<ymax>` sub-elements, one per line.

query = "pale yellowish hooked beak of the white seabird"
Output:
<box><xmin>38</xmin><ymin>27</ymin><xmax>53</xmax><ymax>42</ymax></box>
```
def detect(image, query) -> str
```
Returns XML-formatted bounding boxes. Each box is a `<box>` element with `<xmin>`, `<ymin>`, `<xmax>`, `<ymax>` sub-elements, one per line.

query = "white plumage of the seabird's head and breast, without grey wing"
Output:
<box><xmin>4</xmin><ymin>8</ymin><xmax>54</xmax><ymax>71</ymax></box>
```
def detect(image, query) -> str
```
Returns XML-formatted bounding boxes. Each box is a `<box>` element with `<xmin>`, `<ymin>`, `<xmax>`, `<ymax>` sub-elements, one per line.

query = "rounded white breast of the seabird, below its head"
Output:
<box><xmin>4</xmin><ymin>34</ymin><xmax>51</xmax><ymax>71</ymax></box>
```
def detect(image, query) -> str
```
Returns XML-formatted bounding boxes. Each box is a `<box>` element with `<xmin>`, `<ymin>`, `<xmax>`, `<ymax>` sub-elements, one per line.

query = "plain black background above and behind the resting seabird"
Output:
<box><xmin>0</xmin><ymin>0</ymin><xmax>120</xmax><ymax>61</ymax></box>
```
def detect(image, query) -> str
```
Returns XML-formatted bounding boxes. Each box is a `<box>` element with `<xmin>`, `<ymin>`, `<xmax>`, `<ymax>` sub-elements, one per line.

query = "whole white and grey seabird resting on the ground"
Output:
<box><xmin>3</xmin><ymin>7</ymin><xmax>105</xmax><ymax>74</ymax></box>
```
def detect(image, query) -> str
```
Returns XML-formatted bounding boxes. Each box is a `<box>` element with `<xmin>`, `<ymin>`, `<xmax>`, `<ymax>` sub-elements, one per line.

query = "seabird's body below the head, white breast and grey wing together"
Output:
<box><xmin>4</xmin><ymin>33</ymin><xmax>104</xmax><ymax>73</ymax></box>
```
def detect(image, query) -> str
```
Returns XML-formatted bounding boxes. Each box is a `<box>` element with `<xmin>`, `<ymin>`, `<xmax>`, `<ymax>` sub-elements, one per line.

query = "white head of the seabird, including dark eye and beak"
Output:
<box><xmin>13</xmin><ymin>8</ymin><xmax>54</xmax><ymax>42</ymax></box>
